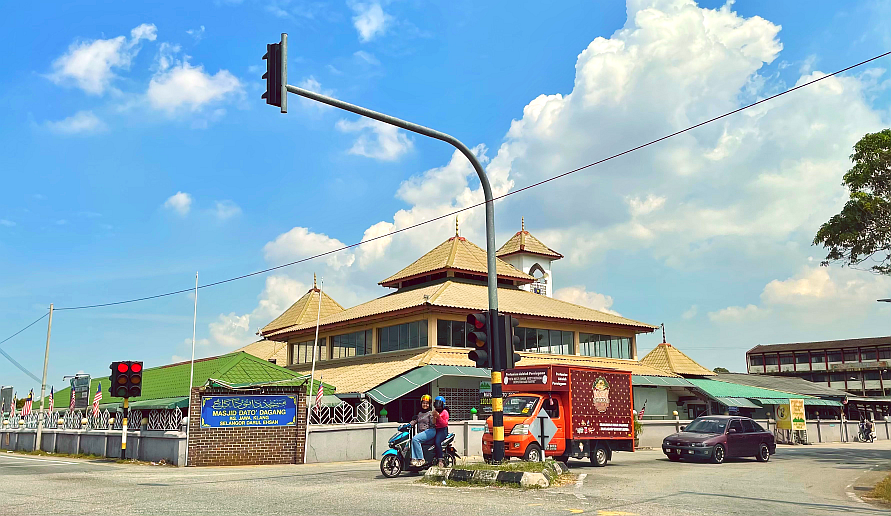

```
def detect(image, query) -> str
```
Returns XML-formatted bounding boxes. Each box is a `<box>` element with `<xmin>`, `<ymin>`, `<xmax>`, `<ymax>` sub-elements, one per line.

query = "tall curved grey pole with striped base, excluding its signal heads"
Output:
<box><xmin>282</xmin><ymin>71</ymin><xmax>505</xmax><ymax>462</ymax></box>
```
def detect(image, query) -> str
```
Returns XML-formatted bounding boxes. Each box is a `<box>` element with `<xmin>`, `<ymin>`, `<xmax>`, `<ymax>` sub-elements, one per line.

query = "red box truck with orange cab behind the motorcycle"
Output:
<box><xmin>483</xmin><ymin>365</ymin><xmax>634</xmax><ymax>466</ymax></box>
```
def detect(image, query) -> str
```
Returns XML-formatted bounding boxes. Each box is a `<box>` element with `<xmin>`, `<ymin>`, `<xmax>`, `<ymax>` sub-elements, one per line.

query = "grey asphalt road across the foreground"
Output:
<box><xmin>0</xmin><ymin>441</ymin><xmax>891</xmax><ymax>516</ymax></box>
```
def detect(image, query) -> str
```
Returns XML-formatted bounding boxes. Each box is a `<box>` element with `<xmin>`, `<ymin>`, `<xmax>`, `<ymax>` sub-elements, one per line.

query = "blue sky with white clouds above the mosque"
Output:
<box><xmin>0</xmin><ymin>0</ymin><xmax>891</xmax><ymax>393</ymax></box>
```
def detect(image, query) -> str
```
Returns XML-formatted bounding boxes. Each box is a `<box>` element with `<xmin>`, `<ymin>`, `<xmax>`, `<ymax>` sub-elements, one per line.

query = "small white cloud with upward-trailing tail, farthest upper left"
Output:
<box><xmin>49</xmin><ymin>23</ymin><xmax>157</xmax><ymax>95</ymax></box>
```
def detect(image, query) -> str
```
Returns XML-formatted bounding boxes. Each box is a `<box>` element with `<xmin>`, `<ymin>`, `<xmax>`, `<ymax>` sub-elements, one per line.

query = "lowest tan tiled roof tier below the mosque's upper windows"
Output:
<box><xmin>289</xmin><ymin>346</ymin><xmax>677</xmax><ymax>394</ymax></box>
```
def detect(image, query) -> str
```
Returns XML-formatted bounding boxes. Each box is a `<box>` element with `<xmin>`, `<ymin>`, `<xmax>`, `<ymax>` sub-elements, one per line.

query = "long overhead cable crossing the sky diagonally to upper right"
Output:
<box><xmin>40</xmin><ymin>52</ymin><xmax>891</xmax><ymax>311</ymax></box>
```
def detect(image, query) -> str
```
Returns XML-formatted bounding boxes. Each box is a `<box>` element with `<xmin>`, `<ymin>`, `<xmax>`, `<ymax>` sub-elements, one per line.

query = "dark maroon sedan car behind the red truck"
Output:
<box><xmin>662</xmin><ymin>416</ymin><xmax>777</xmax><ymax>464</ymax></box>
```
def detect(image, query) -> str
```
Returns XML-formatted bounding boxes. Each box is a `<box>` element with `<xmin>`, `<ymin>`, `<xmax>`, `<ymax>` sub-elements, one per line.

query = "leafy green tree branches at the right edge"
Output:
<box><xmin>814</xmin><ymin>129</ymin><xmax>891</xmax><ymax>275</ymax></box>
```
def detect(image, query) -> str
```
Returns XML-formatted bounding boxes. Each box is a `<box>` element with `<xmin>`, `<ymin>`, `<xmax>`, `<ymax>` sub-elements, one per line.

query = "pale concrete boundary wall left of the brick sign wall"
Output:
<box><xmin>0</xmin><ymin>428</ymin><xmax>186</xmax><ymax>466</ymax></box>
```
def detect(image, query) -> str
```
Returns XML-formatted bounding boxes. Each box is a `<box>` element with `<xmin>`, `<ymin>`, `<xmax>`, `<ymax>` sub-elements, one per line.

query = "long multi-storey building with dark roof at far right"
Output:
<box><xmin>746</xmin><ymin>337</ymin><xmax>891</xmax><ymax>396</ymax></box>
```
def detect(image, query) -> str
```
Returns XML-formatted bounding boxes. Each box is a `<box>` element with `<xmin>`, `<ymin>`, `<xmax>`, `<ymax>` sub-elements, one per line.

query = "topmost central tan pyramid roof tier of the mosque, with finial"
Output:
<box><xmin>380</xmin><ymin>236</ymin><xmax>535</xmax><ymax>287</ymax></box>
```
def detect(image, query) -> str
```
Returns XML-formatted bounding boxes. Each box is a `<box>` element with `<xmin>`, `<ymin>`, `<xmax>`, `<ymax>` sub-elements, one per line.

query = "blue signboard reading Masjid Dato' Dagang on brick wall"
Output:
<box><xmin>201</xmin><ymin>395</ymin><xmax>297</xmax><ymax>428</ymax></box>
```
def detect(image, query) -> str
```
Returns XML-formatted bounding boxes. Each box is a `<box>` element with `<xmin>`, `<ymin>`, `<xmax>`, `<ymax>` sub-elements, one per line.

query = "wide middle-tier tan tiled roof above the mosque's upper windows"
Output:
<box><xmin>266</xmin><ymin>281</ymin><xmax>656</xmax><ymax>337</ymax></box>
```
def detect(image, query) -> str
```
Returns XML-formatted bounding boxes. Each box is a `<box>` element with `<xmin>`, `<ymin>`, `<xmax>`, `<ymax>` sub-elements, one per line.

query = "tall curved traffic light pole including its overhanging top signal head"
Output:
<box><xmin>262</xmin><ymin>33</ymin><xmax>504</xmax><ymax>462</ymax></box>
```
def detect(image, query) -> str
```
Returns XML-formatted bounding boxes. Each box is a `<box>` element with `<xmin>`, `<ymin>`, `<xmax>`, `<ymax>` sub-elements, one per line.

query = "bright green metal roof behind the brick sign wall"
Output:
<box><xmin>54</xmin><ymin>351</ymin><xmax>334</xmax><ymax>410</ymax></box>
